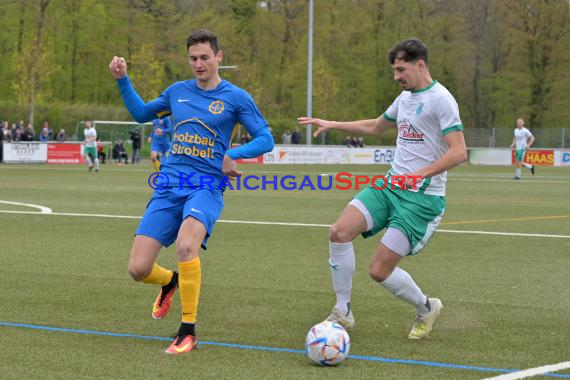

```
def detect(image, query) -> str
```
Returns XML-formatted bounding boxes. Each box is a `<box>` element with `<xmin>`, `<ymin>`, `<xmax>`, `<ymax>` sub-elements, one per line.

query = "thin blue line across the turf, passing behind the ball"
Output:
<box><xmin>0</xmin><ymin>322</ymin><xmax>570</xmax><ymax>379</ymax></box>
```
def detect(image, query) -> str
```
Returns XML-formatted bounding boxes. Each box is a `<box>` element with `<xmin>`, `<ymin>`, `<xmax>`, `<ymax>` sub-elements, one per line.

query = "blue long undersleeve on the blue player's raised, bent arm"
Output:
<box><xmin>117</xmin><ymin>76</ymin><xmax>170</xmax><ymax>123</ymax></box>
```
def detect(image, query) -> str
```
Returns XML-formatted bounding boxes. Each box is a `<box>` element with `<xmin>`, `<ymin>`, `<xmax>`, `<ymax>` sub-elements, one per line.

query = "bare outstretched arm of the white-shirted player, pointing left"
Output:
<box><xmin>297</xmin><ymin>116</ymin><xmax>396</xmax><ymax>137</ymax></box>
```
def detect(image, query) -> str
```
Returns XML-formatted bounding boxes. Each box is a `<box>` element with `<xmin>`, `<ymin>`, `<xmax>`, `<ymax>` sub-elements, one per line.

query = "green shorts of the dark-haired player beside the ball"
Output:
<box><xmin>355</xmin><ymin>181</ymin><xmax>445</xmax><ymax>255</ymax></box>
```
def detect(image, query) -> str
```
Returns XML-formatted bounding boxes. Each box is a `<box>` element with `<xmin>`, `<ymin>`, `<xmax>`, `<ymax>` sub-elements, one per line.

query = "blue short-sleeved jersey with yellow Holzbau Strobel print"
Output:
<box><xmin>153</xmin><ymin>79</ymin><xmax>268</xmax><ymax>187</ymax></box>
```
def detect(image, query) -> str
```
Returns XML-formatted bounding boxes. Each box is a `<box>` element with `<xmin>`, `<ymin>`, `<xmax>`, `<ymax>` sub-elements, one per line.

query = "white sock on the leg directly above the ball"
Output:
<box><xmin>329</xmin><ymin>241</ymin><xmax>355</xmax><ymax>315</ymax></box>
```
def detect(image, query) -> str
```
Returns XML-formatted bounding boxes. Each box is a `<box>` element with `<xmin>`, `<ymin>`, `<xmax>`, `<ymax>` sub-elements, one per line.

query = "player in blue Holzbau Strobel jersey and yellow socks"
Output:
<box><xmin>109</xmin><ymin>29</ymin><xmax>274</xmax><ymax>354</ymax></box>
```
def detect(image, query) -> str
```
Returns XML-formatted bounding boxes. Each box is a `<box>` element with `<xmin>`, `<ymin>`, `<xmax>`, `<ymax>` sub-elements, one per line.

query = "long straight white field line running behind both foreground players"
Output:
<box><xmin>0</xmin><ymin>210</ymin><xmax>570</xmax><ymax>239</ymax></box>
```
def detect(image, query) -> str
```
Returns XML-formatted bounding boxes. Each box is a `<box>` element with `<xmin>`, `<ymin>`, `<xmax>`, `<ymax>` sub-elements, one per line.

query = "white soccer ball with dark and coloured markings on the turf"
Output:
<box><xmin>305</xmin><ymin>321</ymin><xmax>350</xmax><ymax>366</ymax></box>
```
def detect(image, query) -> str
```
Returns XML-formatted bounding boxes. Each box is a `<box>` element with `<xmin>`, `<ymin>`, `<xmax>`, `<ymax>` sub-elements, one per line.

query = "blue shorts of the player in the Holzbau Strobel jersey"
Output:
<box><xmin>135</xmin><ymin>188</ymin><xmax>224</xmax><ymax>249</ymax></box>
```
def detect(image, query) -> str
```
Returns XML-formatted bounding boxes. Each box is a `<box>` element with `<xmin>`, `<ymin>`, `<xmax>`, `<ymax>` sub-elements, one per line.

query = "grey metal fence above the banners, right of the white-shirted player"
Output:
<box><xmin>464</xmin><ymin>128</ymin><xmax>570</xmax><ymax>149</ymax></box>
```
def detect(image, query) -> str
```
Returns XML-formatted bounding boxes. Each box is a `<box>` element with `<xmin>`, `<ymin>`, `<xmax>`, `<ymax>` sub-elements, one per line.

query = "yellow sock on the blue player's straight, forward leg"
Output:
<box><xmin>178</xmin><ymin>257</ymin><xmax>202</xmax><ymax>323</ymax></box>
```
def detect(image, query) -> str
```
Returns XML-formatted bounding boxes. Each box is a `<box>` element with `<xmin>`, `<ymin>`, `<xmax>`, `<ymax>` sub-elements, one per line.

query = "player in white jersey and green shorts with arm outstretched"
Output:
<box><xmin>298</xmin><ymin>39</ymin><xmax>467</xmax><ymax>339</ymax></box>
